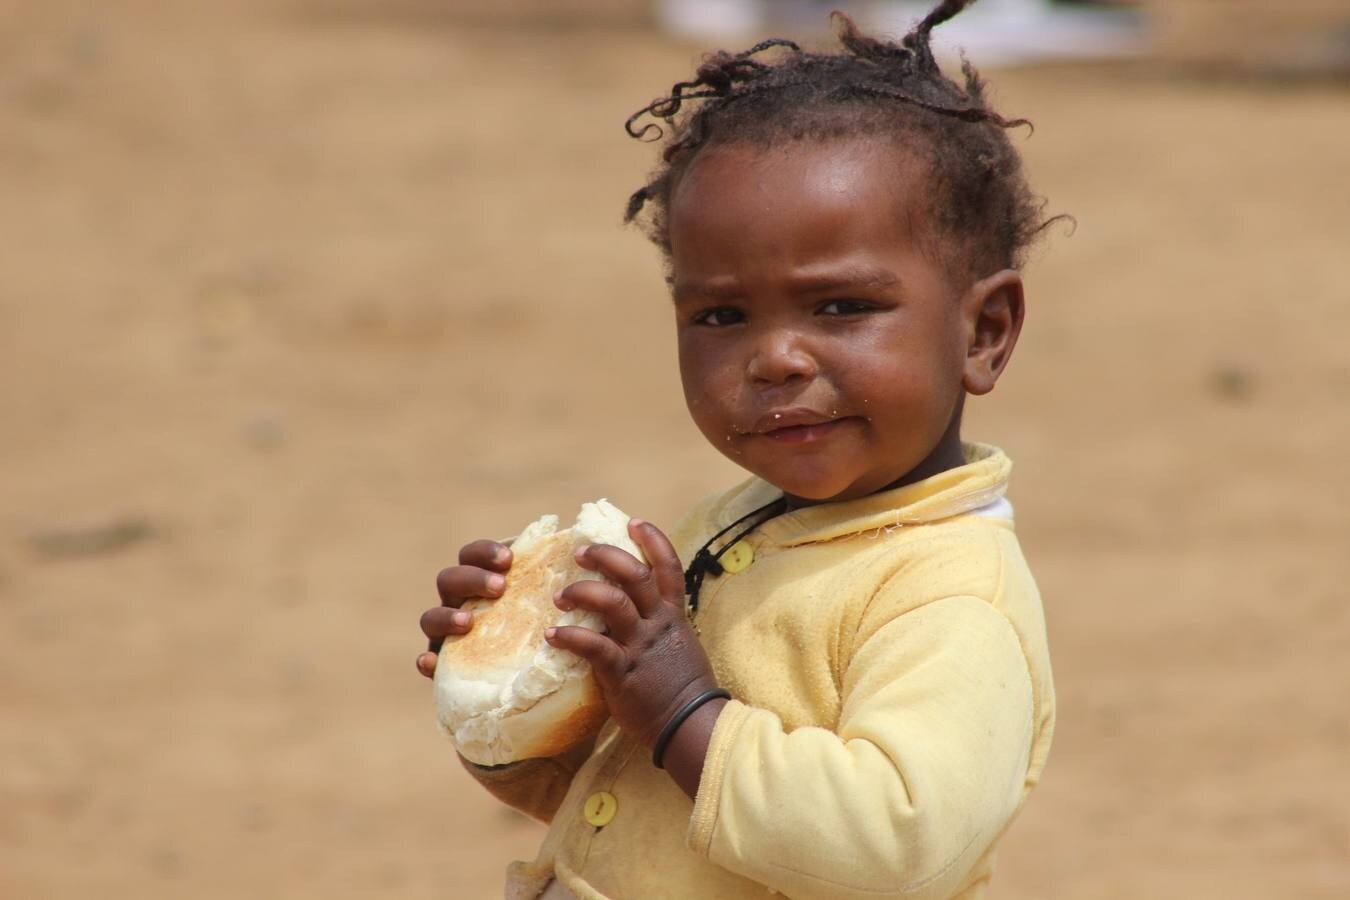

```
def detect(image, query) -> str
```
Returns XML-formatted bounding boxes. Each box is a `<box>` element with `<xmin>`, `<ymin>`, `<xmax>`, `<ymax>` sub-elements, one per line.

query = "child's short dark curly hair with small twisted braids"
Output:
<box><xmin>624</xmin><ymin>0</ymin><xmax>1053</xmax><ymax>281</ymax></box>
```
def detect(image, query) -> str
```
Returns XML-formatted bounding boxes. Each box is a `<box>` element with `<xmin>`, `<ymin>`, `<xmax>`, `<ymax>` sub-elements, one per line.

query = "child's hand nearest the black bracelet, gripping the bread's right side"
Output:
<box><xmin>544</xmin><ymin>518</ymin><xmax>717</xmax><ymax>746</ymax></box>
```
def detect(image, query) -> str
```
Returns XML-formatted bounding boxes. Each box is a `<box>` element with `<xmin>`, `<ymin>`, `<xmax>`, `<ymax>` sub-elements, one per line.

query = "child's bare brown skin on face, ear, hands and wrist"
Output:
<box><xmin>417</xmin><ymin>138</ymin><xmax>1025</xmax><ymax>797</ymax></box>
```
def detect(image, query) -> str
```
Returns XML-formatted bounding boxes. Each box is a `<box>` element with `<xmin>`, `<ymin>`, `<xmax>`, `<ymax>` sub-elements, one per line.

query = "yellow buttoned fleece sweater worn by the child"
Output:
<box><xmin>468</xmin><ymin>444</ymin><xmax>1054</xmax><ymax>900</ymax></box>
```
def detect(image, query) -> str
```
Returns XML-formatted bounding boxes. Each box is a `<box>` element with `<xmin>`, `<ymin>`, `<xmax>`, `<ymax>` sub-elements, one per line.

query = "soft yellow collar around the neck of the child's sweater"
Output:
<box><xmin>718</xmin><ymin>443</ymin><xmax>1013</xmax><ymax>546</ymax></box>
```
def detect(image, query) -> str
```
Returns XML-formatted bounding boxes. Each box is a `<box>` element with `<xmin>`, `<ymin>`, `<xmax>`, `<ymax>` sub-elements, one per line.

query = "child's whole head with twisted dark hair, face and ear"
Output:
<box><xmin>628</xmin><ymin>0</ymin><xmax>1041</xmax><ymax>501</ymax></box>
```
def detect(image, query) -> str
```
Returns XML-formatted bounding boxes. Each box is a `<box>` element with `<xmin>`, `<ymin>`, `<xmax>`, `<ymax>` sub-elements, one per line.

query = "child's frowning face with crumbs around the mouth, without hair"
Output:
<box><xmin>670</xmin><ymin>139</ymin><xmax>1021</xmax><ymax>501</ymax></box>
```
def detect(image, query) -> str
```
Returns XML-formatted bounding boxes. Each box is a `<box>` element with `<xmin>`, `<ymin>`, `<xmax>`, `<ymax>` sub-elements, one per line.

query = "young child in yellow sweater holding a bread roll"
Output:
<box><xmin>417</xmin><ymin>0</ymin><xmax>1054</xmax><ymax>900</ymax></box>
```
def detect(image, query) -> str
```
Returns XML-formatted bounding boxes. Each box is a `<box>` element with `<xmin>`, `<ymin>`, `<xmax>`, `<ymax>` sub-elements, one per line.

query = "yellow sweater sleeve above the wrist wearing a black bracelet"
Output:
<box><xmin>689</xmin><ymin>596</ymin><xmax>1033</xmax><ymax>900</ymax></box>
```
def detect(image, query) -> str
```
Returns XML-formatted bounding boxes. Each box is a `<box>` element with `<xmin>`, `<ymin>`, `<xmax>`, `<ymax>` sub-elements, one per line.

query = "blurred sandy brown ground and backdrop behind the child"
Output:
<box><xmin>0</xmin><ymin>0</ymin><xmax>1350</xmax><ymax>899</ymax></box>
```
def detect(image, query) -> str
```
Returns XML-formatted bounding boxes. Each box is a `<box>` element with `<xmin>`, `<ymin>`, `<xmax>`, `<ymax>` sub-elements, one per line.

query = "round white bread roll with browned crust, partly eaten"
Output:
<box><xmin>435</xmin><ymin>499</ymin><xmax>644</xmax><ymax>765</ymax></box>
